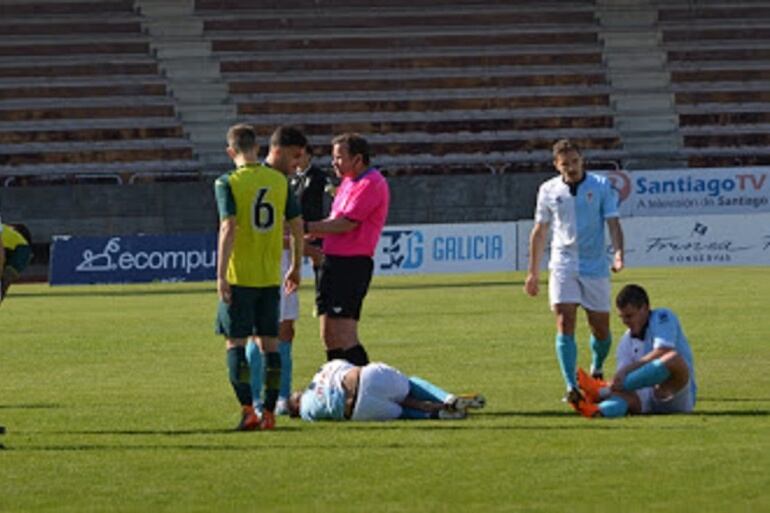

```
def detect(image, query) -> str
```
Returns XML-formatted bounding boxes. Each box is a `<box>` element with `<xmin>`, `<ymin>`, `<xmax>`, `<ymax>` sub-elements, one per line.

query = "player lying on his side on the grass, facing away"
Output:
<box><xmin>289</xmin><ymin>360</ymin><xmax>486</xmax><ymax>421</ymax></box>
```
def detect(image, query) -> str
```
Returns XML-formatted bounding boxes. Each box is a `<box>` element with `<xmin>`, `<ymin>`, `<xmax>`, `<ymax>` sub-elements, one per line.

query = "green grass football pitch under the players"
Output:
<box><xmin>0</xmin><ymin>267</ymin><xmax>770</xmax><ymax>513</ymax></box>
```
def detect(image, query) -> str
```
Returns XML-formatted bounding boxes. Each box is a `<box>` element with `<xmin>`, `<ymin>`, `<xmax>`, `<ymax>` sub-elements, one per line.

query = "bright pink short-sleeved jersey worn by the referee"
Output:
<box><xmin>323</xmin><ymin>168</ymin><xmax>390</xmax><ymax>257</ymax></box>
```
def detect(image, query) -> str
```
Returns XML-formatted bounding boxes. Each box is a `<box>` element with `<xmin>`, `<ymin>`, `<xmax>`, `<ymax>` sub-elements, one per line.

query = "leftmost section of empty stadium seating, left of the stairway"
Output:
<box><xmin>0</xmin><ymin>0</ymin><xmax>199</xmax><ymax>184</ymax></box>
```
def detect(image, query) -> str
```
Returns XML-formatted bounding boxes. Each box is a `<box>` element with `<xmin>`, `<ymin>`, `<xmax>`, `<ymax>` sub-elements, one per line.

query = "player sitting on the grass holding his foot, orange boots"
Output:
<box><xmin>574</xmin><ymin>285</ymin><xmax>697</xmax><ymax>417</ymax></box>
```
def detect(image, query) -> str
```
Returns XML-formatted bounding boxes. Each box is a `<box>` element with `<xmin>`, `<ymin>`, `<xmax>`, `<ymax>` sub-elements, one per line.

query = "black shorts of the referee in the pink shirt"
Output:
<box><xmin>315</xmin><ymin>255</ymin><xmax>374</xmax><ymax>320</ymax></box>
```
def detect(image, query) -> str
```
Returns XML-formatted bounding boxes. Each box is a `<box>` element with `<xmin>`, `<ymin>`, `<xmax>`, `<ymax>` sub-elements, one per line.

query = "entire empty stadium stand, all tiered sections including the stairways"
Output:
<box><xmin>0</xmin><ymin>0</ymin><xmax>770</xmax><ymax>184</ymax></box>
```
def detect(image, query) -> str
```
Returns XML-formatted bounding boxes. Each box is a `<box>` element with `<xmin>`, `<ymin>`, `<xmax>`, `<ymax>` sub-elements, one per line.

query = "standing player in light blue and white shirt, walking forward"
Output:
<box><xmin>524</xmin><ymin>140</ymin><xmax>623</xmax><ymax>404</ymax></box>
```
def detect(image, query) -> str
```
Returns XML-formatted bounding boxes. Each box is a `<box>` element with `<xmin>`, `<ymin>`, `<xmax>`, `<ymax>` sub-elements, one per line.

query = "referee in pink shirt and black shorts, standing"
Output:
<box><xmin>305</xmin><ymin>133</ymin><xmax>390</xmax><ymax>366</ymax></box>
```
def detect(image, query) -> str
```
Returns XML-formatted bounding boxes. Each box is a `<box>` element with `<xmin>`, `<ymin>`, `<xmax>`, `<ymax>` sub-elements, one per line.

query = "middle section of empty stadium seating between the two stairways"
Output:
<box><xmin>195</xmin><ymin>0</ymin><xmax>623</xmax><ymax>174</ymax></box>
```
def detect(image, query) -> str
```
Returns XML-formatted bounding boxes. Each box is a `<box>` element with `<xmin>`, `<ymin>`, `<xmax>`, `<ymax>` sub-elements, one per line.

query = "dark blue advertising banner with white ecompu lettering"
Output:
<box><xmin>49</xmin><ymin>233</ymin><xmax>217</xmax><ymax>285</ymax></box>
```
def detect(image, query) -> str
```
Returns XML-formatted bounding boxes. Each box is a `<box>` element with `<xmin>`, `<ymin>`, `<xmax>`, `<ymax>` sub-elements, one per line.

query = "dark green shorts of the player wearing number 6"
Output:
<box><xmin>216</xmin><ymin>285</ymin><xmax>281</xmax><ymax>338</ymax></box>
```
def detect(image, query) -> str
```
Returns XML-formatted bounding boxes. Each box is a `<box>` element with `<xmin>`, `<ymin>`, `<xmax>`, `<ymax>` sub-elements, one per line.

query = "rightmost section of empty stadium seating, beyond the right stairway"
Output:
<box><xmin>659</xmin><ymin>0</ymin><xmax>770</xmax><ymax>167</ymax></box>
